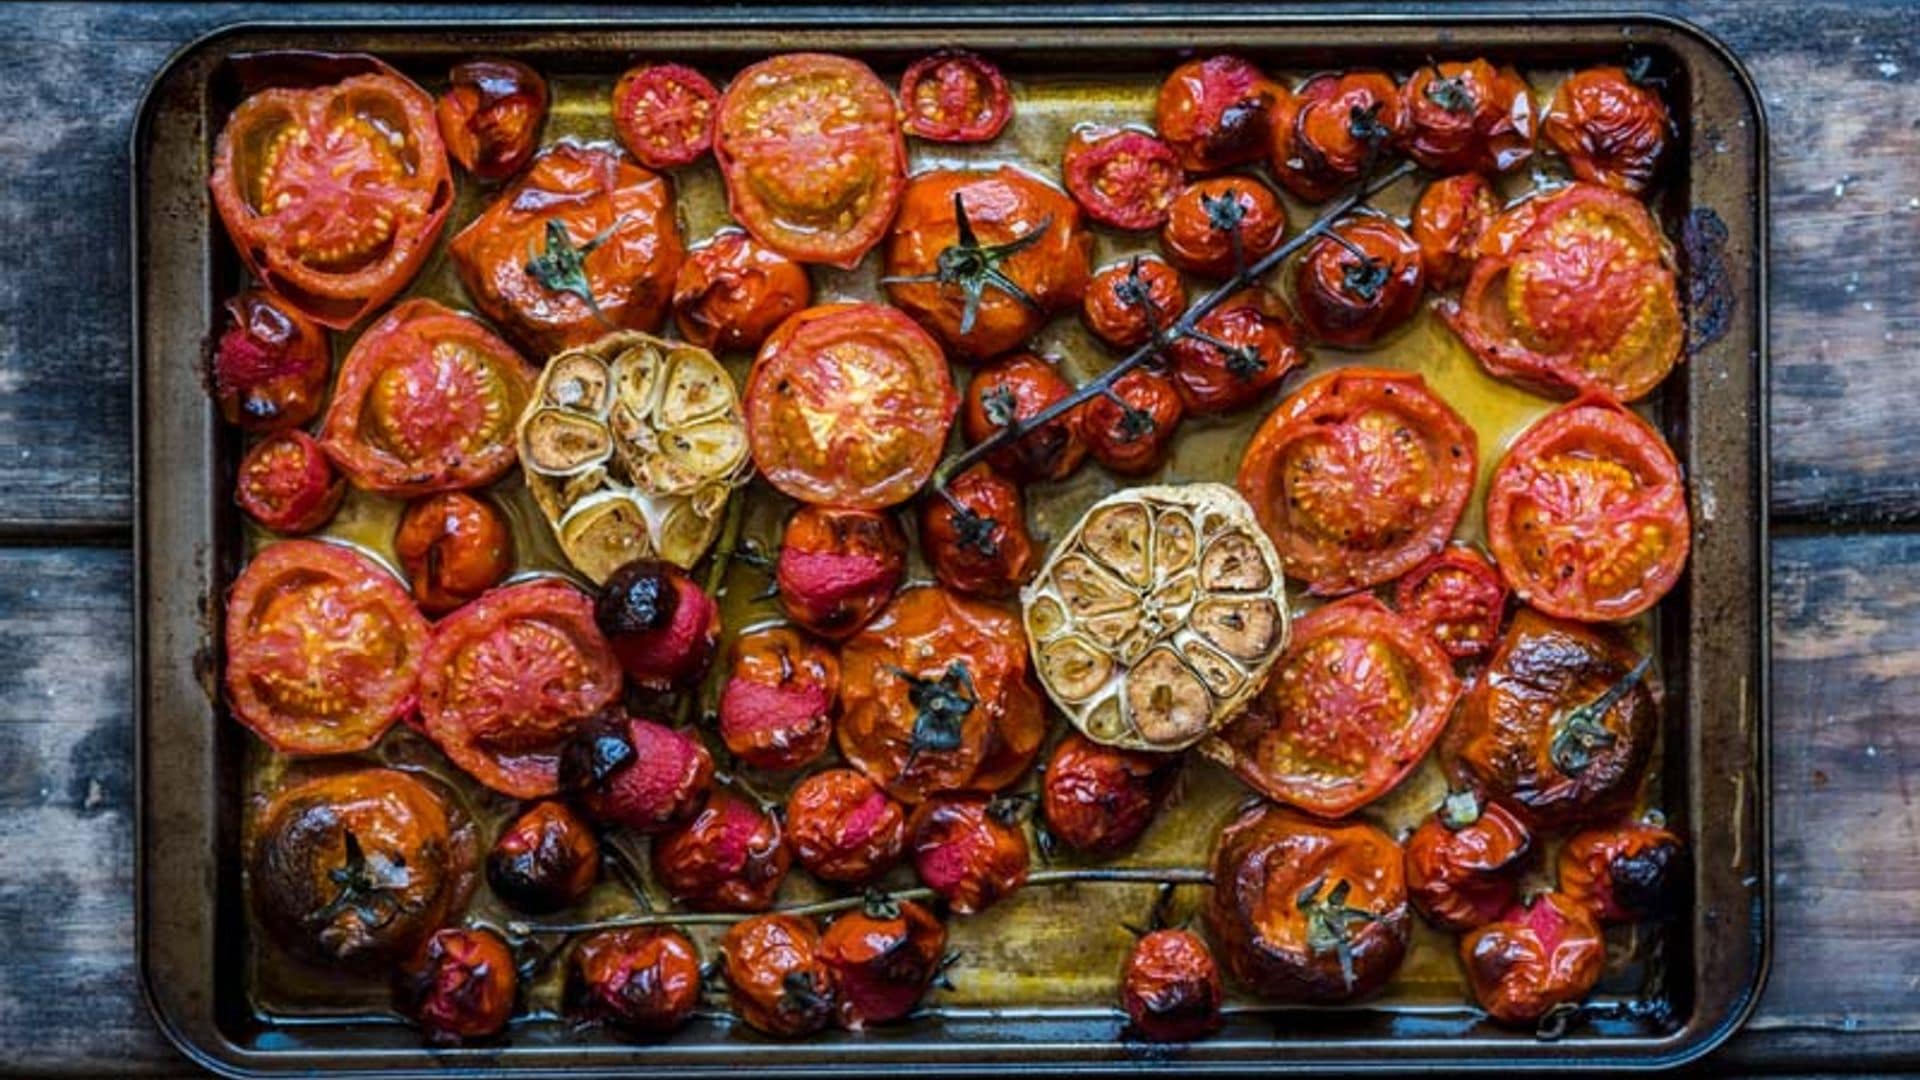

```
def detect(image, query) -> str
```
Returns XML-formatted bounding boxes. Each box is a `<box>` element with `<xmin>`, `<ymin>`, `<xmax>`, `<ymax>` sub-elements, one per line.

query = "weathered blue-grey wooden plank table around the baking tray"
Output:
<box><xmin>0</xmin><ymin>0</ymin><xmax>1920</xmax><ymax>1074</ymax></box>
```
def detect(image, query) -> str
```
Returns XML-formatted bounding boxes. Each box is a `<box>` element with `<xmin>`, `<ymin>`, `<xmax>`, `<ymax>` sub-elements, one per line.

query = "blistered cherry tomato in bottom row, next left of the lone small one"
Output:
<box><xmin>820</xmin><ymin>896</ymin><xmax>947</xmax><ymax>1032</ymax></box>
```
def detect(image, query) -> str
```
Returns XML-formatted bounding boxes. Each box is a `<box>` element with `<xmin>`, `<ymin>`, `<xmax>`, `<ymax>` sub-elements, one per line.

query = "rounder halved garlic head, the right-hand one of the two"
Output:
<box><xmin>1020</xmin><ymin>484</ymin><xmax>1288</xmax><ymax>749</ymax></box>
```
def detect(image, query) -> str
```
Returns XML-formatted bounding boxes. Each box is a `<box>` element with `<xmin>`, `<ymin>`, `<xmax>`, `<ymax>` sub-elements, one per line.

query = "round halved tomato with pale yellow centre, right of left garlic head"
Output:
<box><xmin>747</xmin><ymin>304</ymin><xmax>960</xmax><ymax>509</ymax></box>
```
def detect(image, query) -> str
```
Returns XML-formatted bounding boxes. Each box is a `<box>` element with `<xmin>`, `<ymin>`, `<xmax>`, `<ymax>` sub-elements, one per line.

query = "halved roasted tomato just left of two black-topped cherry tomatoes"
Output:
<box><xmin>420</xmin><ymin>580</ymin><xmax>620</xmax><ymax>799</ymax></box>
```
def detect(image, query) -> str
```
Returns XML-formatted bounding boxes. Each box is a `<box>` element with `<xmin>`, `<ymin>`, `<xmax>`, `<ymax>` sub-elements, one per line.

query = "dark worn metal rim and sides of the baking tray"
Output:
<box><xmin>132</xmin><ymin>4</ymin><xmax>1768</xmax><ymax>1076</ymax></box>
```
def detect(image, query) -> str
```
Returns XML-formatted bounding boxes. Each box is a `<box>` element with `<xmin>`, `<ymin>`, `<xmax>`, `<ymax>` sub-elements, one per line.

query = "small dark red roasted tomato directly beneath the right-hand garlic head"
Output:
<box><xmin>1041</xmin><ymin>732</ymin><xmax>1181</xmax><ymax>855</ymax></box>
